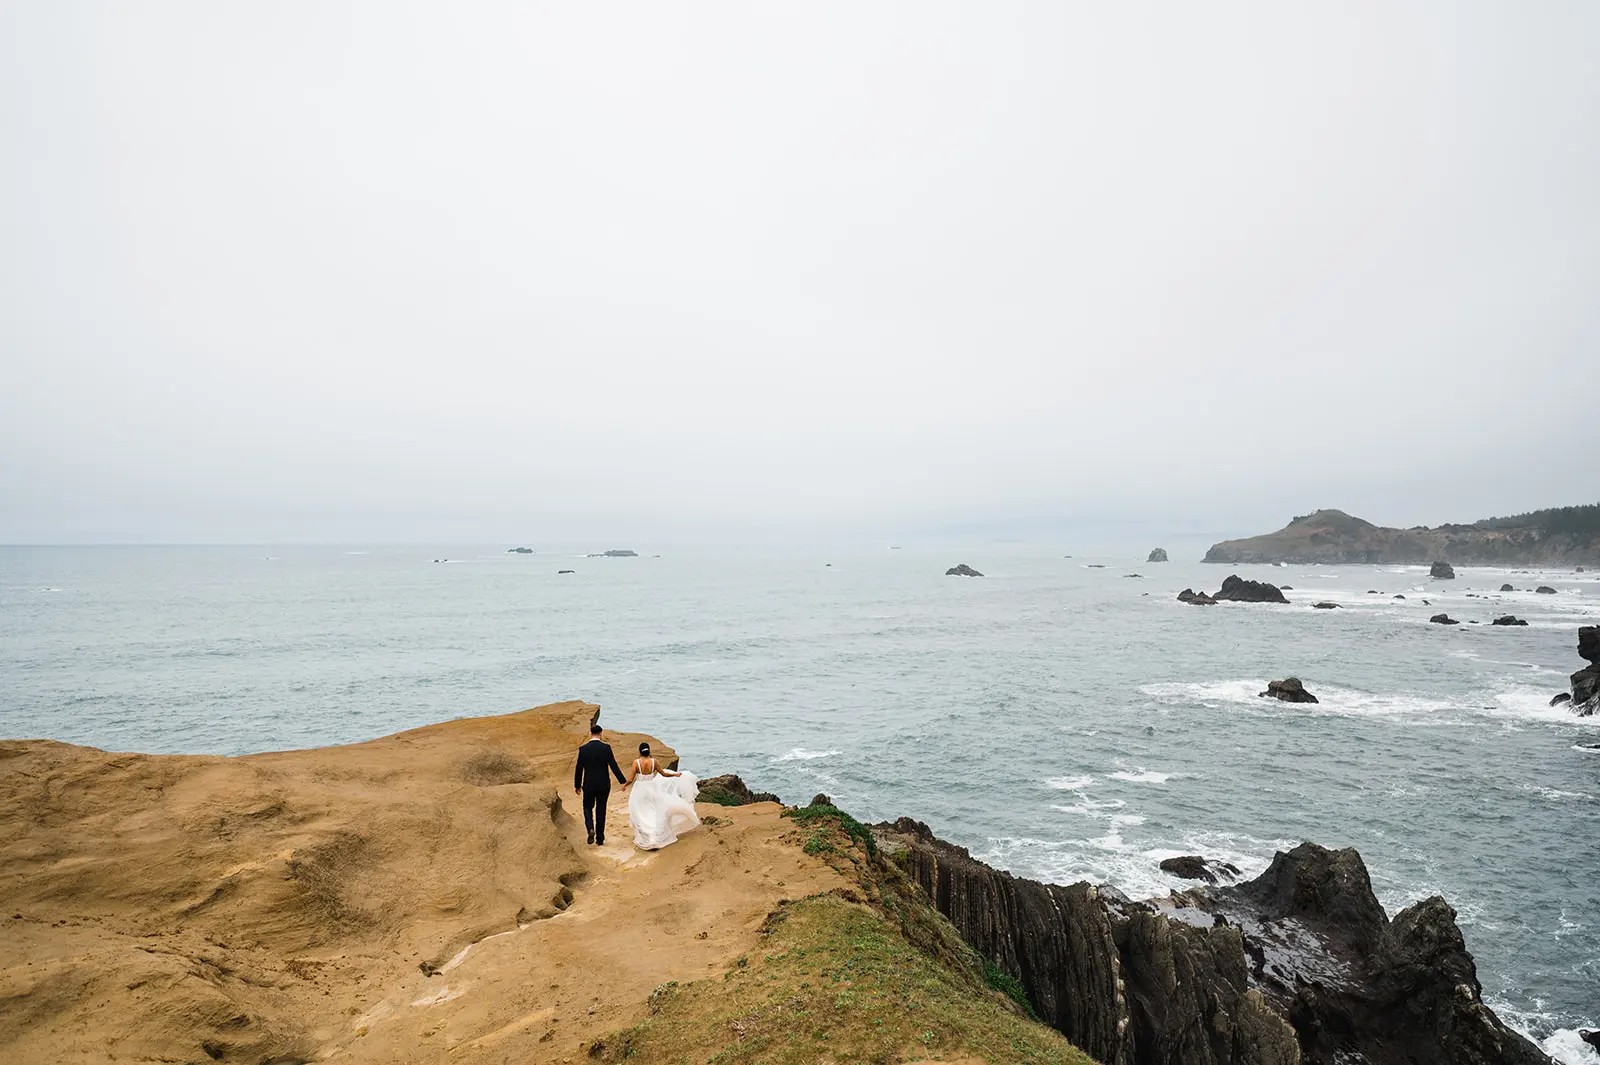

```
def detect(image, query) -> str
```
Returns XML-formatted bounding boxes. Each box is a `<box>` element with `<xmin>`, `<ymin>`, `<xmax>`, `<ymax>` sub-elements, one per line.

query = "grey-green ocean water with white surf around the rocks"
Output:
<box><xmin>0</xmin><ymin>544</ymin><xmax>1600</xmax><ymax>1063</ymax></box>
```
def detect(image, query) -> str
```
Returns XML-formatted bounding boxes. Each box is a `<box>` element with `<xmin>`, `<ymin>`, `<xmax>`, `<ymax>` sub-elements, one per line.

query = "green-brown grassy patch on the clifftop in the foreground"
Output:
<box><xmin>592</xmin><ymin>895</ymin><xmax>1093</xmax><ymax>1065</ymax></box>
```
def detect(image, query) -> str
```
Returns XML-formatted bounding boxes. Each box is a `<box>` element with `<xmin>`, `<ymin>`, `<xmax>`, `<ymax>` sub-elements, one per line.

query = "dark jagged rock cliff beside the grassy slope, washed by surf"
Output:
<box><xmin>877</xmin><ymin>819</ymin><xmax>1549</xmax><ymax>1065</ymax></box>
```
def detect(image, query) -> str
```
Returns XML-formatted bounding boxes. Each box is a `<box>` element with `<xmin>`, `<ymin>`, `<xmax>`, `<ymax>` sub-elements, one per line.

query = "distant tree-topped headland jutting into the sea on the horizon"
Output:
<box><xmin>1205</xmin><ymin>504</ymin><xmax>1600</xmax><ymax>566</ymax></box>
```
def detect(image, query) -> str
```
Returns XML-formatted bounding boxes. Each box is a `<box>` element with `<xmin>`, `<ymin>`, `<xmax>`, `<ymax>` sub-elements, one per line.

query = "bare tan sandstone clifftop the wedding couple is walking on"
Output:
<box><xmin>0</xmin><ymin>702</ymin><xmax>842</xmax><ymax>1063</ymax></box>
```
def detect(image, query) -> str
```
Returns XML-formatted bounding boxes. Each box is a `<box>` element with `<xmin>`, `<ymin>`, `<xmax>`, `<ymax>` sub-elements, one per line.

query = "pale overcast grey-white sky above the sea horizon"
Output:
<box><xmin>0</xmin><ymin>0</ymin><xmax>1600</xmax><ymax>545</ymax></box>
